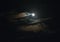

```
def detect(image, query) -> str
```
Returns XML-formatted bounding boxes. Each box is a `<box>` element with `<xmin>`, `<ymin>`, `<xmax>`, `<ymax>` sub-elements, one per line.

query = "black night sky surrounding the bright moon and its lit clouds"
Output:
<box><xmin>0</xmin><ymin>0</ymin><xmax>60</xmax><ymax>41</ymax></box>
